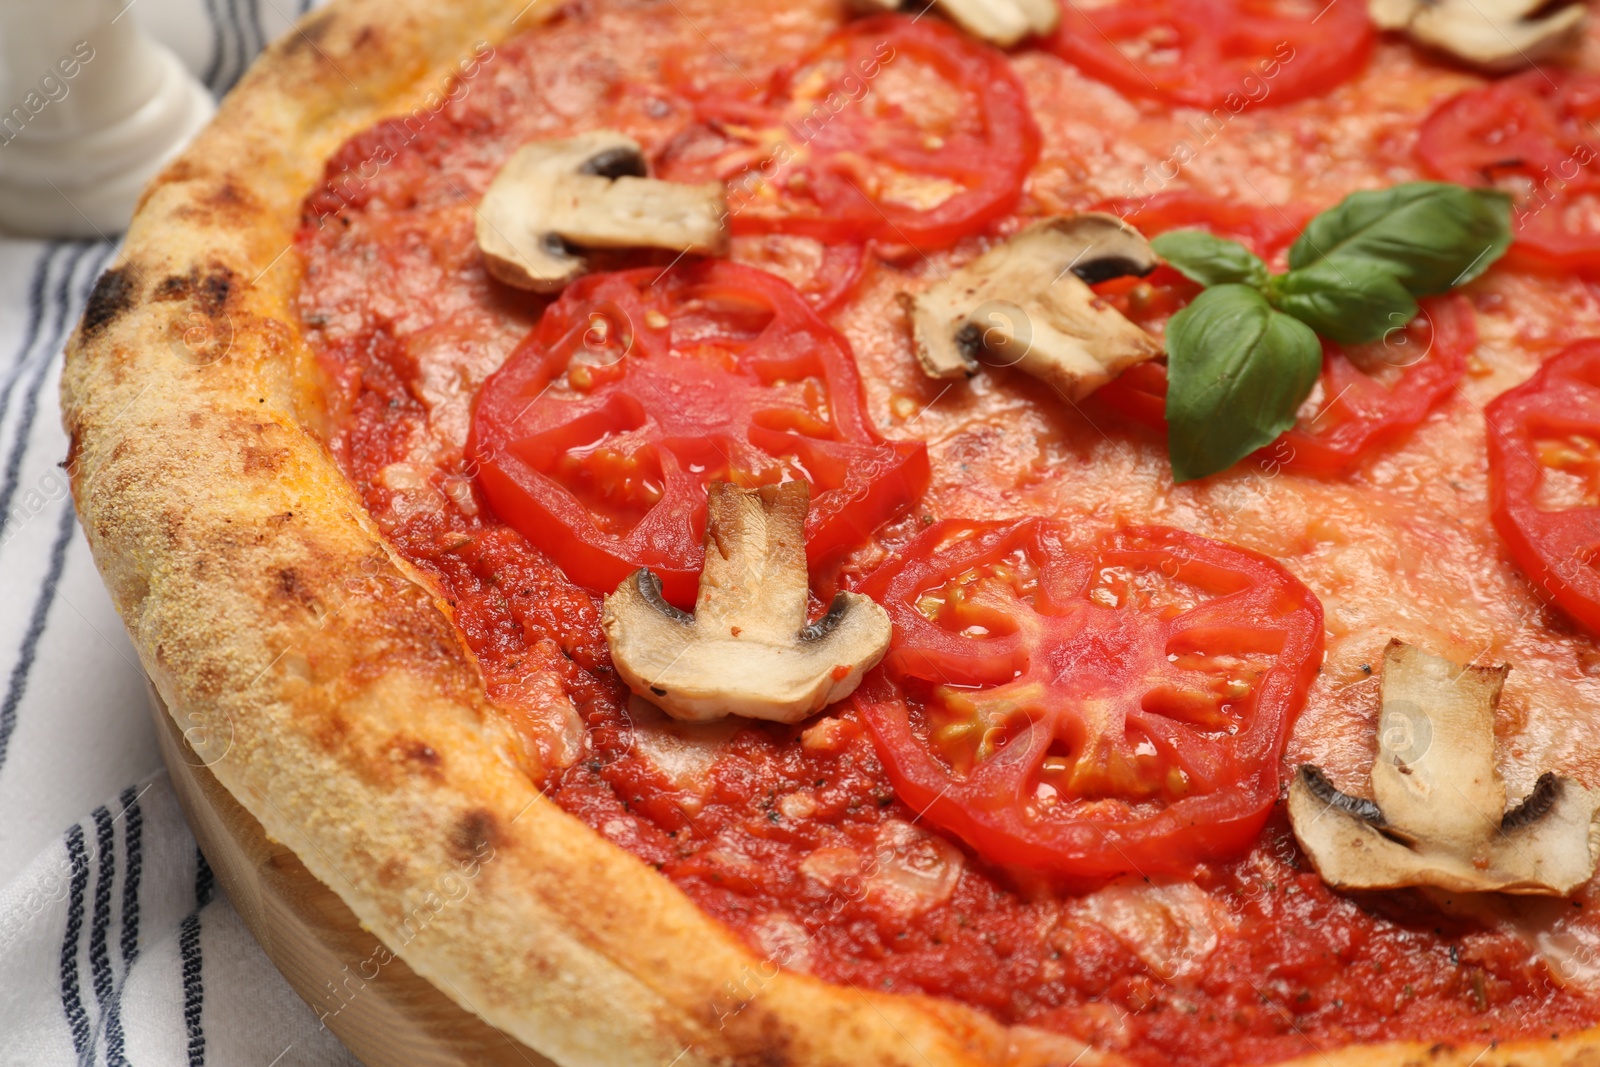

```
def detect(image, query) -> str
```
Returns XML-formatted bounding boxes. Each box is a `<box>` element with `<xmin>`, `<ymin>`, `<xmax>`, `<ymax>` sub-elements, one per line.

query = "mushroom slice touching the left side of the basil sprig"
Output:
<box><xmin>901</xmin><ymin>211</ymin><xmax>1162</xmax><ymax>400</ymax></box>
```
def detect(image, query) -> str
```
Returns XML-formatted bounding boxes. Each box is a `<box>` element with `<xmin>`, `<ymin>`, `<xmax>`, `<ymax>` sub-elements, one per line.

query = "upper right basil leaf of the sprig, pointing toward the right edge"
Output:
<box><xmin>1290</xmin><ymin>181</ymin><xmax>1512</xmax><ymax>296</ymax></box>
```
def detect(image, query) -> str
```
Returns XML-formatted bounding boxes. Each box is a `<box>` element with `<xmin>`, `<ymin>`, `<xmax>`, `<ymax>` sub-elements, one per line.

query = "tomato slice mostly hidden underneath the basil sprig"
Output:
<box><xmin>1096</xmin><ymin>194</ymin><xmax>1478</xmax><ymax>477</ymax></box>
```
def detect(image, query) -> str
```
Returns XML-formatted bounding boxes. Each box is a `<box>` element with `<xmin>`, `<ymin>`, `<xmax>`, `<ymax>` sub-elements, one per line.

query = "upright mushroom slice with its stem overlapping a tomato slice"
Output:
<box><xmin>602</xmin><ymin>482</ymin><xmax>890</xmax><ymax>723</ymax></box>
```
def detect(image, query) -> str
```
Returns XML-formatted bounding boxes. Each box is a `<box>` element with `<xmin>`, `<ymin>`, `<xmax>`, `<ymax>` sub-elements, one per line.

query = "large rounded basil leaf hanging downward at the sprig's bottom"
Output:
<box><xmin>1166</xmin><ymin>285</ymin><xmax>1322</xmax><ymax>482</ymax></box>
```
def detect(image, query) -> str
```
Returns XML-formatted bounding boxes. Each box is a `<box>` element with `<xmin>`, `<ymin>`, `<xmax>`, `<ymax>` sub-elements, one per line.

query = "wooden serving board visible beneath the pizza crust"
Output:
<box><xmin>150</xmin><ymin>688</ymin><xmax>555</xmax><ymax>1067</ymax></box>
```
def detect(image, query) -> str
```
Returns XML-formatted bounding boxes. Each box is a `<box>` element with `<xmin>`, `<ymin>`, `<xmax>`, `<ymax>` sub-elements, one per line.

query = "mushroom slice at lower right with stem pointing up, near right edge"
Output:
<box><xmin>1288</xmin><ymin>641</ymin><xmax>1600</xmax><ymax>896</ymax></box>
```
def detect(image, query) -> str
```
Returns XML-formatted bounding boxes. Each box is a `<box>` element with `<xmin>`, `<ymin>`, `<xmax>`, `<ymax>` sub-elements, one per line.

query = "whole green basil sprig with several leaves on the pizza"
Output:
<box><xmin>1150</xmin><ymin>182</ymin><xmax>1512</xmax><ymax>482</ymax></box>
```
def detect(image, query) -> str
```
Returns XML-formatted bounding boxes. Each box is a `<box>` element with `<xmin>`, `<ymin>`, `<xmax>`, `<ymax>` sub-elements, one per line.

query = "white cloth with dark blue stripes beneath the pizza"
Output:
<box><xmin>0</xmin><ymin>0</ymin><xmax>357</xmax><ymax>1067</ymax></box>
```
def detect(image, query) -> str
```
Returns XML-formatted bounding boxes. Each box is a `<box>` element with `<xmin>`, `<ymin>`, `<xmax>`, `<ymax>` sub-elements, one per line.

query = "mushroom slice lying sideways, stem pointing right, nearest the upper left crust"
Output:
<box><xmin>477</xmin><ymin>130</ymin><xmax>728</xmax><ymax>293</ymax></box>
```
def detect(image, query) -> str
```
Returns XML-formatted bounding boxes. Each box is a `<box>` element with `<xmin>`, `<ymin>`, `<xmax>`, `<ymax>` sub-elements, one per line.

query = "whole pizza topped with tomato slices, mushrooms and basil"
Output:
<box><xmin>62</xmin><ymin>0</ymin><xmax>1600</xmax><ymax>1067</ymax></box>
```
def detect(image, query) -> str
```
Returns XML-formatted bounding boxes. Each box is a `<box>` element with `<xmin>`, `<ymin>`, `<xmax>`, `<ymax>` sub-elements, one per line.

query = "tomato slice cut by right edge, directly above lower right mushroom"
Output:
<box><xmin>1483</xmin><ymin>339</ymin><xmax>1600</xmax><ymax>635</ymax></box>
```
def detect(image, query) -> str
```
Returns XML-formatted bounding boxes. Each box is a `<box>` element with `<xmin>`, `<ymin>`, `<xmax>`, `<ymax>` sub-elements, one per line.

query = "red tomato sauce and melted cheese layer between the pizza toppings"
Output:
<box><xmin>298</xmin><ymin>0</ymin><xmax>1600</xmax><ymax>1067</ymax></box>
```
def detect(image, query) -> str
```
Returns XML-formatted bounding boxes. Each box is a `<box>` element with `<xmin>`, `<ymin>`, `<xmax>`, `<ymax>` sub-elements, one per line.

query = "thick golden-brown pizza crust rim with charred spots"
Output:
<box><xmin>62</xmin><ymin>0</ymin><xmax>1600</xmax><ymax>1067</ymax></box>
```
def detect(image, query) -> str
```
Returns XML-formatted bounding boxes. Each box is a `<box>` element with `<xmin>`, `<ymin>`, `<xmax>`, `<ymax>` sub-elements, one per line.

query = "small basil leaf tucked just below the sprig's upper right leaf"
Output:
<box><xmin>1267</xmin><ymin>259</ymin><xmax>1416</xmax><ymax>344</ymax></box>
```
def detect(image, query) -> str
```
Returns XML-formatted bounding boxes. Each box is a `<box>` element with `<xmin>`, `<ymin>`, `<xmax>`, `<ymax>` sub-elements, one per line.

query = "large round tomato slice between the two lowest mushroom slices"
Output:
<box><xmin>853</xmin><ymin>518</ymin><xmax>1323</xmax><ymax>881</ymax></box>
